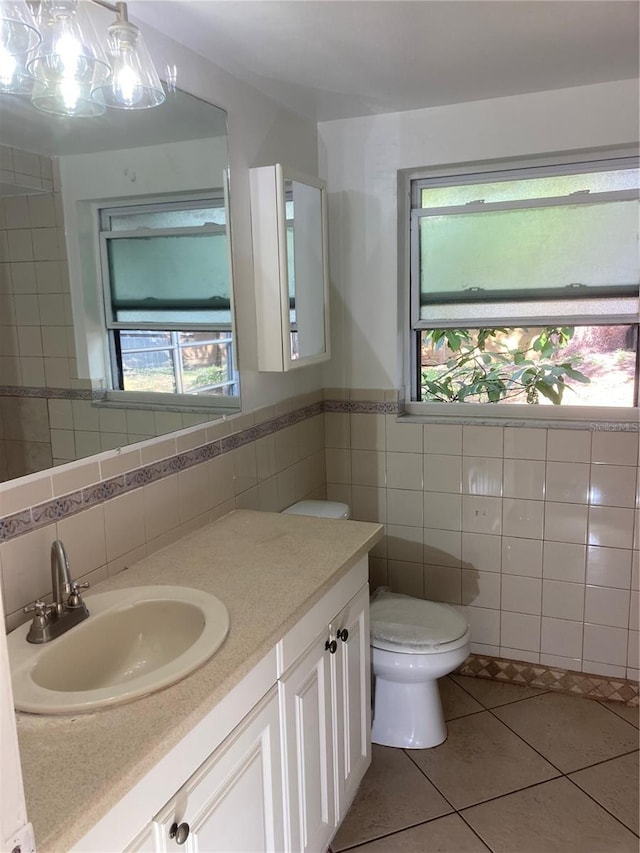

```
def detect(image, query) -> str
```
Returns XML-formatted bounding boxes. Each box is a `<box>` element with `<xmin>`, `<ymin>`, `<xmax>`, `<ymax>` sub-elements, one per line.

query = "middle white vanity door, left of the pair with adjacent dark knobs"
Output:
<box><xmin>279</xmin><ymin>632</ymin><xmax>335</xmax><ymax>853</ymax></box>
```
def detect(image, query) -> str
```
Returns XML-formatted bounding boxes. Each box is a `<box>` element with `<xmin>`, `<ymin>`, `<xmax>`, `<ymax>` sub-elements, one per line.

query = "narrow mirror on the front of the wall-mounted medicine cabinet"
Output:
<box><xmin>284</xmin><ymin>180</ymin><xmax>326</xmax><ymax>359</ymax></box>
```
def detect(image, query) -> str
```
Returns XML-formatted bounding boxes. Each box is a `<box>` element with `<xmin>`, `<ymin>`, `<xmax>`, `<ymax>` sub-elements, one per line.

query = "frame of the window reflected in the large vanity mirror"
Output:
<box><xmin>96</xmin><ymin>193</ymin><xmax>240</xmax><ymax>406</ymax></box>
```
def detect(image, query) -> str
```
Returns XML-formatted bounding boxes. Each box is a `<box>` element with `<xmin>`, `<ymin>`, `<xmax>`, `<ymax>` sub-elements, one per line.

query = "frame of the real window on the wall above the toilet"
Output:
<box><xmin>398</xmin><ymin>147</ymin><xmax>640</xmax><ymax>412</ymax></box>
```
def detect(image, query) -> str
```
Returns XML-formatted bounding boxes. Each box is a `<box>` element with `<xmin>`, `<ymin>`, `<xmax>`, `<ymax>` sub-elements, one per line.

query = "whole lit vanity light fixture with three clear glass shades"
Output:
<box><xmin>0</xmin><ymin>0</ymin><xmax>165</xmax><ymax>117</ymax></box>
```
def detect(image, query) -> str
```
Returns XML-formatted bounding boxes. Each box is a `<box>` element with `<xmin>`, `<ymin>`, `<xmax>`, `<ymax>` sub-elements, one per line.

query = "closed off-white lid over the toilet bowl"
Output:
<box><xmin>370</xmin><ymin>592</ymin><xmax>468</xmax><ymax>649</ymax></box>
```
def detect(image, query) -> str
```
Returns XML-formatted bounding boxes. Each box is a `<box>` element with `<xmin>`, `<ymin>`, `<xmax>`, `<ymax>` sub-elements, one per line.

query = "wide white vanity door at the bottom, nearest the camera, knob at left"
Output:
<box><xmin>154</xmin><ymin>687</ymin><xmax>284</xmax><ymax>853</ymax></box>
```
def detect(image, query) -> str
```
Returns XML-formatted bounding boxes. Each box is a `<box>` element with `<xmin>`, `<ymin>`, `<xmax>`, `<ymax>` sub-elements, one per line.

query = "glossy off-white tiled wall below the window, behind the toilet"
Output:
<box><xmin>325</xmin><ymin>396</ymin><xmax>640</xmax><ymax>678</ymax></box>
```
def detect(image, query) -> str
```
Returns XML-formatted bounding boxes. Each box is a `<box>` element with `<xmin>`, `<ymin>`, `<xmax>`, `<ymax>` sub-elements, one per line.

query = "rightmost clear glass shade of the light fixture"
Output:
<box><xmin>93</xmin><ymin>21</ymin><xmax>165</xmax><ymax>110</ymax></box>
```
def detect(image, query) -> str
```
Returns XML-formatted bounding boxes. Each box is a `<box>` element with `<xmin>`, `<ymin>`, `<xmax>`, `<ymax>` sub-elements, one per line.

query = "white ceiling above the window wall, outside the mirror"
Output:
<box><xmin>129</xmin><ymin>0</ymin><xmax>640</xmax><ymax>121</ymax></box>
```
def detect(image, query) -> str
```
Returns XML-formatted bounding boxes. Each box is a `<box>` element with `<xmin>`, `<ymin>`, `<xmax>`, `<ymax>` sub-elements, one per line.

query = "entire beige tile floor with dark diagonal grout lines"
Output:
<box><xmin>331</xmin><ymin>675</ymin><xmax>640</xmax><ymax>853</ymax></box>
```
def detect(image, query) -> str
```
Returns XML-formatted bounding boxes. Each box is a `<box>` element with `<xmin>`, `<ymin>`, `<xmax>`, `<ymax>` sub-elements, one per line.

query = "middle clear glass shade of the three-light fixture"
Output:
<box><xmin>27</xmin><ymin>0</ymin><xmax>110</xmax><ymax>88</ymax></box>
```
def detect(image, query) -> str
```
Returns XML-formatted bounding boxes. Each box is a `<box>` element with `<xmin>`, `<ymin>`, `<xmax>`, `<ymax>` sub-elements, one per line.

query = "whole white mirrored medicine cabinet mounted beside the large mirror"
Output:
<box><xmin>250</xmin><ymin>164</ymin><xmax>330</xmax><ymax>372</ymax></box>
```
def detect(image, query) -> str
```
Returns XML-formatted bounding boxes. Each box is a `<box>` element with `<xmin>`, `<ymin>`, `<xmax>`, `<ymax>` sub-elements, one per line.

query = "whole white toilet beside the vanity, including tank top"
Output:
<box><xmin>283</xmin><ymin>501</ymin><xmax>471</xmax><ymax>749</ymax></box>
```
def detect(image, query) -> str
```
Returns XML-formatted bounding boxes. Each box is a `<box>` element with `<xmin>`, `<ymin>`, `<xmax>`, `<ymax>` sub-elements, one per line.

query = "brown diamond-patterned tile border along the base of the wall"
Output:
<box><xmin>456</xmin><ymin>654</ymin><xmax>638</xmax><ymax>707</ymax></box>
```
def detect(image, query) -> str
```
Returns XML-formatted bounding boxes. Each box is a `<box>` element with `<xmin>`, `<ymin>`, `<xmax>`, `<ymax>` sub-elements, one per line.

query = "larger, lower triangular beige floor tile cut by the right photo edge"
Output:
<box><xmin>570</xmin><ymin>752</ymin><xmax>640</xmax><ymax>834</ymax></box>
